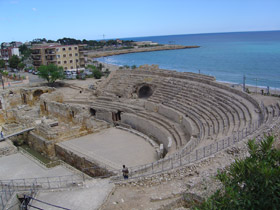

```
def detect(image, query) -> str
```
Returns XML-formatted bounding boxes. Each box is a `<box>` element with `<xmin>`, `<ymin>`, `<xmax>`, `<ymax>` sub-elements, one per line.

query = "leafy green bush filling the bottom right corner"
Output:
<box><xmin>194</xmin><ymin>136</ymin><xmax>280</xmax><ymax>210</ymax></box>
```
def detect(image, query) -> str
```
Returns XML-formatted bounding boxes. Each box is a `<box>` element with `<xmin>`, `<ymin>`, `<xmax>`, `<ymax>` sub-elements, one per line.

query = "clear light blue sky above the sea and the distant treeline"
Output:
<box><xmin>0</xmin><ymin>0</ymin><xmax>280</xmax><ymax>43</ymax></box>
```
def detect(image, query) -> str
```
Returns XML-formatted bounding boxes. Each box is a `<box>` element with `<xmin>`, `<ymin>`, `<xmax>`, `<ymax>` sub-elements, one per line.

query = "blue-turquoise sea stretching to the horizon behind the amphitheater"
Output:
<box><xmin>98</xmin><ymin>31</ymin><xmax>280</xmax><ymax>88</ymax></box>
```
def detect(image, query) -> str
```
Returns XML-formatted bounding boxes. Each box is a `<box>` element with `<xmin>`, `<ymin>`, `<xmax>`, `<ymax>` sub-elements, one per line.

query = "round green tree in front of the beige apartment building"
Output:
<box><xmin>38</xmin><ymin>64</ymin><xmax>64</xmax><ymax>83</ymax></box>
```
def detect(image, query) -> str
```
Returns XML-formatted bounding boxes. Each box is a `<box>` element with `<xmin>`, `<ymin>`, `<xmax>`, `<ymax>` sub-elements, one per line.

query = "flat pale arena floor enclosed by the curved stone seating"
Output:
<box><xmin>59</xmin><ymin>128</ymin><xmax>157</xmax><ymax>169</ymax></box>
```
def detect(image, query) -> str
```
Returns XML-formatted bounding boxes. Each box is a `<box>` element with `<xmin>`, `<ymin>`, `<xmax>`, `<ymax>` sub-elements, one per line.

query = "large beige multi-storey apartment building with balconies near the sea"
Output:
<box><xmin>32</xmin><ymin>44</ymin><xmax>85</xmax><ymax>70</ymax></box>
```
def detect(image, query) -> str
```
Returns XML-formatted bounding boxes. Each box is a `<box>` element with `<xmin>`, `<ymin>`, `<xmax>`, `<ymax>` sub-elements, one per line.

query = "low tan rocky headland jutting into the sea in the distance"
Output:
<box><xmin>87</xmin><ymin>45</ymin><xmax>200</xmax><ymax>58</ymax></box>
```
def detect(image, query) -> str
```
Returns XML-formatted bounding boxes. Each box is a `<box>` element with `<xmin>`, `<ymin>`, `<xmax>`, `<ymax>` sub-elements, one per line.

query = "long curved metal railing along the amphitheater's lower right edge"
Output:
<box><xmin>112</xmin><ymin>107</ymin><xmax>280</xmax><ymax>182</ymax></box>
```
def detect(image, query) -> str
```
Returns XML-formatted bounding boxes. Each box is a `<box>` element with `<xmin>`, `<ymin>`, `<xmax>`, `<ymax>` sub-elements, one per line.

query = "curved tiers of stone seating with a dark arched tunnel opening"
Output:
<box><xmin>92</xmin><ymin>66</ymin><xmax>263</xmax><ymax>156</ymax></box>
